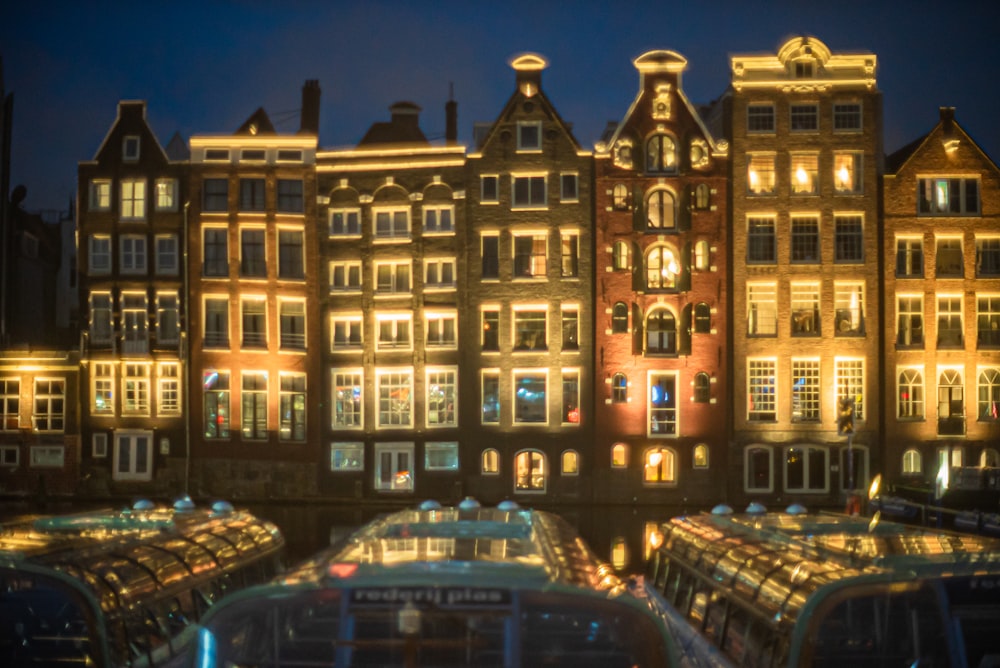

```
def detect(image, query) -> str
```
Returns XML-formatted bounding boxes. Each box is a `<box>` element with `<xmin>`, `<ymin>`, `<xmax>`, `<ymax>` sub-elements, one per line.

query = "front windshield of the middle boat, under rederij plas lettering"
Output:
<box><xmin>198</xmin><ymin>586</ymin><xmax>669</xmax><ymax>668</ymax></box>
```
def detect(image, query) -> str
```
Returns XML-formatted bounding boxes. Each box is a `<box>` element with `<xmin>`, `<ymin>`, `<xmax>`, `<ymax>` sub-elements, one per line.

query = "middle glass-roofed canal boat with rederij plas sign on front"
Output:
<box><xmin>191</xmin><ymin>499</ymin><xmax>677</xmax><ymax>668</ymax></box>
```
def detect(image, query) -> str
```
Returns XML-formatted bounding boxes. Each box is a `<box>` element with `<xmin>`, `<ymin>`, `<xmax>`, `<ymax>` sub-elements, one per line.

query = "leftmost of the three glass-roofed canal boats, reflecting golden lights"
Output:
<box><xmin>0</xmin><ymin>498</ymin><xmax>285</xmax><ymax>668</ymax></box>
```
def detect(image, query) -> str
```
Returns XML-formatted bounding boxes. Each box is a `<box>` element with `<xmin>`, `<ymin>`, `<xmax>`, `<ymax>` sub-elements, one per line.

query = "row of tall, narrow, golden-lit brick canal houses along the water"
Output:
<box><xmin>0</xmin><ymin>37</ymin><xmax>1000</xmax><ymax>506</ymax></box>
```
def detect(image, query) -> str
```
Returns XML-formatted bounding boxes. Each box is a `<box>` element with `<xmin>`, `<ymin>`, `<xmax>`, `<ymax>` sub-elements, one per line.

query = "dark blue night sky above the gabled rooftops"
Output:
<box><xmin>0</xmin><ymin>0</ymin><xmax>1000</xmax><ymax>210</ymax></box>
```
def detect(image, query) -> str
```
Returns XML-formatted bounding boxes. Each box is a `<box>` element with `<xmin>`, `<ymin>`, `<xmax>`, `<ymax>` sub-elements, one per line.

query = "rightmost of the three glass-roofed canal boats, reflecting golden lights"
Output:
<box><xmin>645</xmin><ymin>504</ymin><xmax>1000</xmax><ymax>668</ymax></box>
